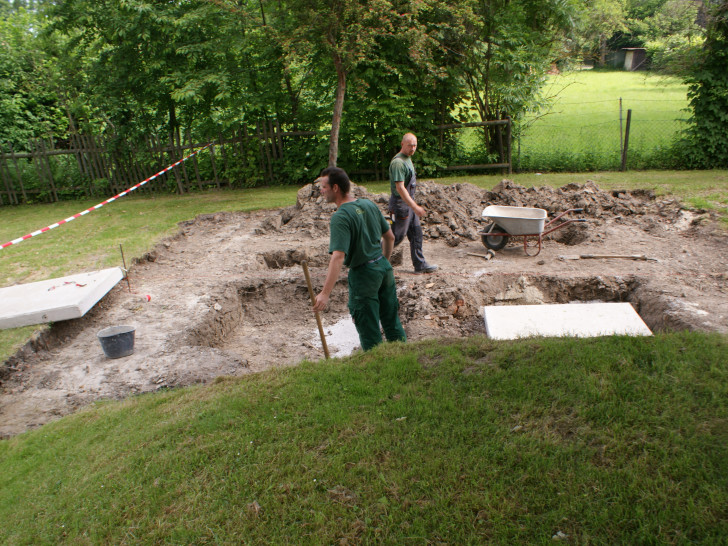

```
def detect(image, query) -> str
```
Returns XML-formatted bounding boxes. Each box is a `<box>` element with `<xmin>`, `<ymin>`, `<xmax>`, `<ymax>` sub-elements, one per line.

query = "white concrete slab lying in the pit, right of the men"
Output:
<box><xmin>483</xmin><ymin>303</ymin><xmax>652</xmax><ymax>339</ymax></box>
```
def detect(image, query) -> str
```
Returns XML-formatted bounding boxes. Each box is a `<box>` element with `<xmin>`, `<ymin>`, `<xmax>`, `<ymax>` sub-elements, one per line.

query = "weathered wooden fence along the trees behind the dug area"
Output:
<box><xmin>0</xmin><ymin>119</ymin><xmax>511</xmax><ymax>205</ymax></box>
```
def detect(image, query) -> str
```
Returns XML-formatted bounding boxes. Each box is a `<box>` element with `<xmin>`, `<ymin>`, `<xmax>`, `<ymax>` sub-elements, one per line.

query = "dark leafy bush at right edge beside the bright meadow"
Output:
<box><xmin>684</xmin><ymin>2</ymin><xmax>728</xmax><ymax>168</ymax></box>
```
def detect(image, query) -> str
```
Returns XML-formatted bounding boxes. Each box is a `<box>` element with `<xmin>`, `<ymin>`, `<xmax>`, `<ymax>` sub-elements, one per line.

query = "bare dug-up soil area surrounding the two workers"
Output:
<box><xmin>0</xmin><ymin>180</ymin><xmax>728</xmax><ymax>437</ymax></box>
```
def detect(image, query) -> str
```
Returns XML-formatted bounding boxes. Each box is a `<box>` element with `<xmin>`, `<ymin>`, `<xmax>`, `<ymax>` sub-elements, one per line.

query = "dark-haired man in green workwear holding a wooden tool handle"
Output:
<box><xmin>313</xmin><ymin>167</ymin><xmax>407</xmax><ymax>351</ymax></box>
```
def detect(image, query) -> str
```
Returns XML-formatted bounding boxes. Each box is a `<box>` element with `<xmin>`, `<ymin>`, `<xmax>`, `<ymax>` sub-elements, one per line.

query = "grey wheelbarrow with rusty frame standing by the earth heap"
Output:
<box><xmin>478</xmin><ymin>205</ymin><xmax>586</xmax><ymax>256</ymax></box>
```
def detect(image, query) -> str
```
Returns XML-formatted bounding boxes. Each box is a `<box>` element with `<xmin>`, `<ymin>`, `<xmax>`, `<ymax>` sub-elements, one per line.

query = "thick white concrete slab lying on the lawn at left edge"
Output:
<box><xmin>0</xmin><ymin>267</ymin><xmax>124</xmax><ymax>330</ymax></box>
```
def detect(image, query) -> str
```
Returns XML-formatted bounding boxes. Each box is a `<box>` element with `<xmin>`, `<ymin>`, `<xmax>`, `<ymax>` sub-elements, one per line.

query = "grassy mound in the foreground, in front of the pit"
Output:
<box><xmin>0</xmin><ymin>333</ymin><xmax>728</xmax><ymax>544</ymax></box>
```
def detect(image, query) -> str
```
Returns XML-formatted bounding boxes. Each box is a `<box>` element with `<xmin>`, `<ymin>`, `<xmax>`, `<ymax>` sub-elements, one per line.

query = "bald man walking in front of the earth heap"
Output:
<box><xmin>389</xmin><ymin>133</ymin><xmax>437</xmax><ymax>273</ymax></box>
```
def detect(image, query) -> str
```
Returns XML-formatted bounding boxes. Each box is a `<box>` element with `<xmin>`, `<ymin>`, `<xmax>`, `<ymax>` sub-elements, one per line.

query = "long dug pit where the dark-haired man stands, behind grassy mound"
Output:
<box><xmin>184</xmin><ymin>275</ymin><xmax>686</xmax><ymax>370</ymax></box>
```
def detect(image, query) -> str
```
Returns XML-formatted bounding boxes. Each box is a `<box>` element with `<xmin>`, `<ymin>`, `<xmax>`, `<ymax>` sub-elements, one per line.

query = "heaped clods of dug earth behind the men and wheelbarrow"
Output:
<box><xmin>256</xmin><ymin>179</ymin><xmax>700</xmax><ymax>248</ymax></box>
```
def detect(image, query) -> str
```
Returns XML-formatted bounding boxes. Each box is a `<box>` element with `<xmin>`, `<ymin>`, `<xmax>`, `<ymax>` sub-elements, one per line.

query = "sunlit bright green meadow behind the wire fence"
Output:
<box><xmin>514</xmin><ymin>70</ymin><xmax>688</xmax><ymax>171</ymax></box>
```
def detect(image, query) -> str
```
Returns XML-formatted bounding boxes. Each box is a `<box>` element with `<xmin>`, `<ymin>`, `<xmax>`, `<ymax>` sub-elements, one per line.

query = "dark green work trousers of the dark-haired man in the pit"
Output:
<box><xmin>349</xmin><ymin>258</ymin><xmax>407</xmax><ymax>351</ymax></box>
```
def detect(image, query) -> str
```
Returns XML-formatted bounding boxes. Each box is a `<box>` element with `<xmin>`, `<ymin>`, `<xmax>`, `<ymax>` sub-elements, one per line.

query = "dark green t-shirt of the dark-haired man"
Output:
<box><xmin>329</xmin><ymin>199</ymin><xmax>389</xmax><ymax>267</ymax></box>
